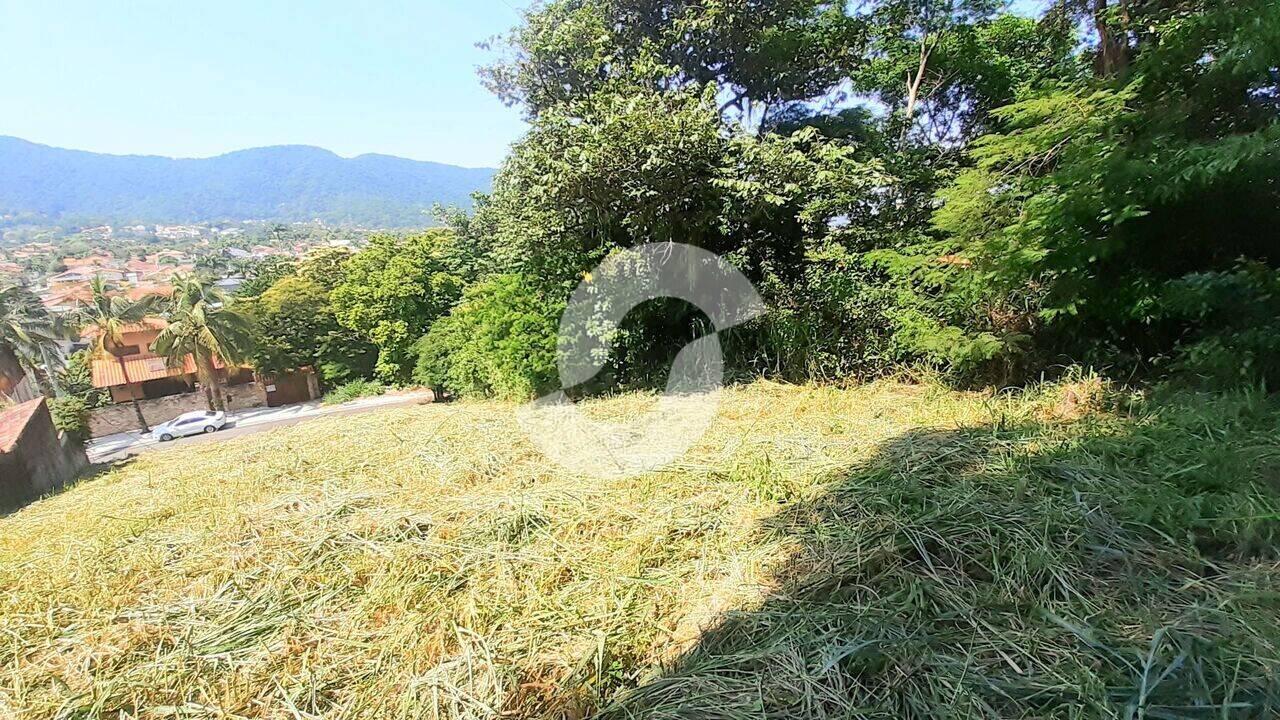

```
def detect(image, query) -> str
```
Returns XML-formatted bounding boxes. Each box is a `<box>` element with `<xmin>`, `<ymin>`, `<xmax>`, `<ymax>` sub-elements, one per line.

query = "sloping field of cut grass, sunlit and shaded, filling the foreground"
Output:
<box><xmin>0</xmin><ymin>382</ymin><xmax>1280</xmax><ymax>720</ymax></box>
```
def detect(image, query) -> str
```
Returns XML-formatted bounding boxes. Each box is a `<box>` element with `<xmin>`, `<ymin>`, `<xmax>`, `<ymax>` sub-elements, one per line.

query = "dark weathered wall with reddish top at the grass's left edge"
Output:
<box><xmin>0</xmin><ymin>398</ymin><xmax>88</xmax><ymax>511</ymax></box>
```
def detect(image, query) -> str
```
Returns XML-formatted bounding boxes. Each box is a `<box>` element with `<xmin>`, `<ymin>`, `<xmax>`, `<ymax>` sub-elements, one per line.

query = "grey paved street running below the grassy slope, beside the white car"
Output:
<box><xmin>84</xmin><ymin>391</ymin><xmax>431</xmax><ymax>464</ymax></box>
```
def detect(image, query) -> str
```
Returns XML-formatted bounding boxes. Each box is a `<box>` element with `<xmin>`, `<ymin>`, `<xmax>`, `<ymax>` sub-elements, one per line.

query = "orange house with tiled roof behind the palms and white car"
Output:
<box><xmin>87</xmin><ymin>318</ymin><xmax>253</xmax><ymax>402</ymax></box>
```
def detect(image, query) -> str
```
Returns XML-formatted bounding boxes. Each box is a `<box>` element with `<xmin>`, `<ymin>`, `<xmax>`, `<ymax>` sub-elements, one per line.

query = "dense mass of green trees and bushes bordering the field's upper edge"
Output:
<box><xmin>350</xmin><ymin>0</ymin><xmax>1280</xmax><ymax>395</ymax></box>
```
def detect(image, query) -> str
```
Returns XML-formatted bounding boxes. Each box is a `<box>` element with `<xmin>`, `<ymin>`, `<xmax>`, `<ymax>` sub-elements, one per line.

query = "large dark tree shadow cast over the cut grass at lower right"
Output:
<box><xmin>602</xmin><ymin>400</ymin><xmax>1280</xmax><ymax>719</ymax></box>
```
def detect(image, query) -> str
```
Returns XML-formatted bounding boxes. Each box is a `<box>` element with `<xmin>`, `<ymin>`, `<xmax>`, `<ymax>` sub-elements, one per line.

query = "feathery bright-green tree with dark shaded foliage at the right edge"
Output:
<box><xmin>921</xmin><ymin>0</ymin><xmax>1280</xmax><ymax>381</ymax></box>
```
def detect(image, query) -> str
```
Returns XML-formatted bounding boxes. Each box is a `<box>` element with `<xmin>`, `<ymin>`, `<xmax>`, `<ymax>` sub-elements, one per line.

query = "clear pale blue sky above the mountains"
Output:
<box><xmin>0</xmin><ymin>0</ymin><xmax>1033</xmax><ymax>167</ymax></box>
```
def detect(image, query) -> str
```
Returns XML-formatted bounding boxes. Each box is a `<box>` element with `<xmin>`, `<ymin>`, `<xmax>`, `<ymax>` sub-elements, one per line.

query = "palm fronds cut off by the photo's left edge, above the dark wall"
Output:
<box><xmin>0</xmin><ymin>284</ymin><xmax>68</xmax><ymax>392</ymax></box>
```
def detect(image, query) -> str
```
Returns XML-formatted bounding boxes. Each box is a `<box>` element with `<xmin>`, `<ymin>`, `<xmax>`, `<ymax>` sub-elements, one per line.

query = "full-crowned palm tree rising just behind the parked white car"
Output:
<box><xmin>152</xmin><ymin>275</ymin><xmax>252</xmax><ymax>410</ymax></box>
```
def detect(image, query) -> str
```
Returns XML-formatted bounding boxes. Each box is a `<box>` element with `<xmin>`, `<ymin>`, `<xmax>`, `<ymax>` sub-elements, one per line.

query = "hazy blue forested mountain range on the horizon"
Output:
<box><xmin>0</xmin><ymin>136</ymin><xmax>494</xmax><ymax>227</ymax></box>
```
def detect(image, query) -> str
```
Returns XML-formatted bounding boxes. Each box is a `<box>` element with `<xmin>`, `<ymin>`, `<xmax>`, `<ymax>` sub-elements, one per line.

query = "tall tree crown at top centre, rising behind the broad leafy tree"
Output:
<box><xmin>481</xmin><ymin>0</ymin><xmax>864</xmax><ymax>118</ymax></box>
